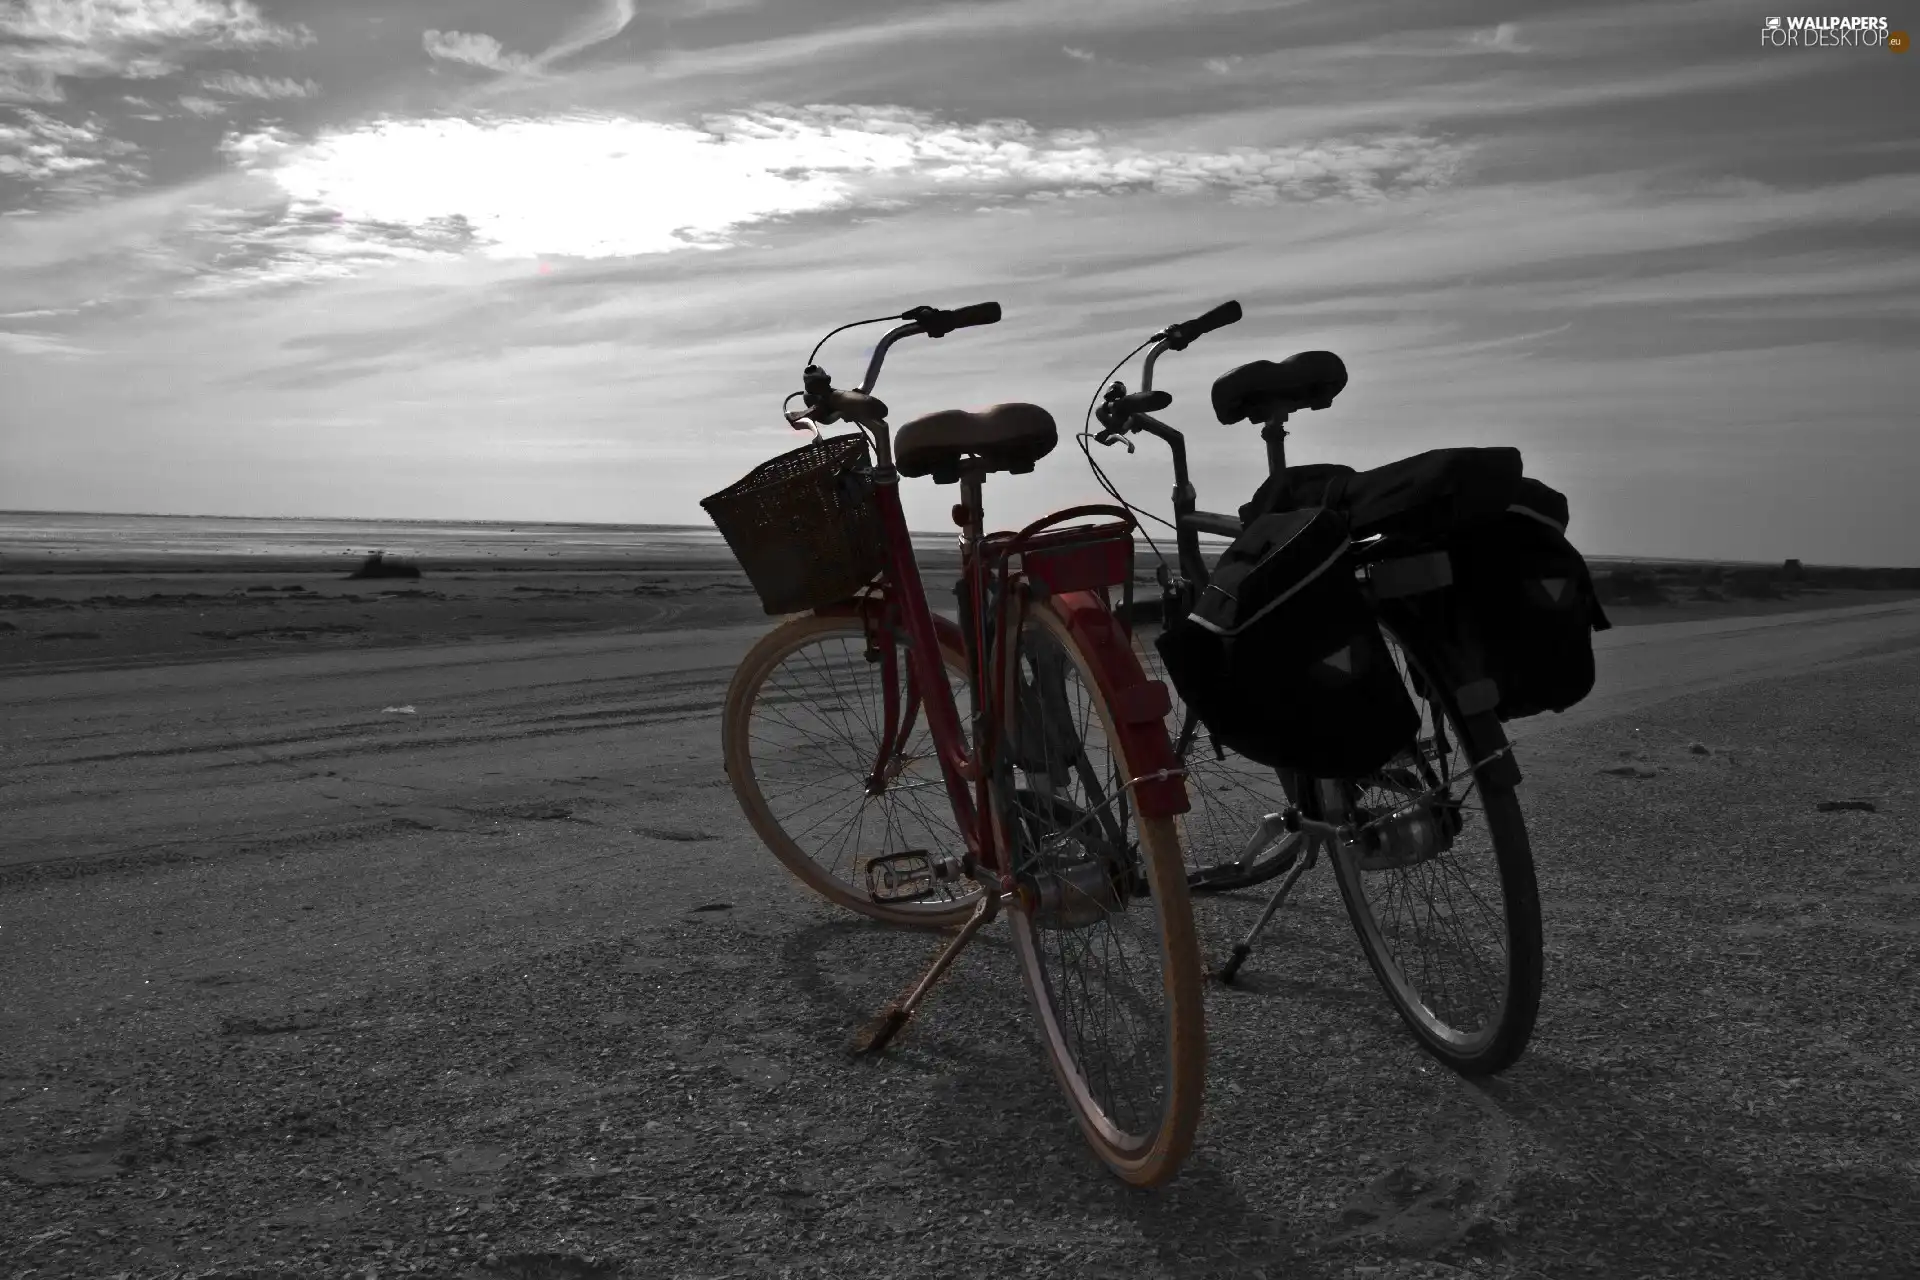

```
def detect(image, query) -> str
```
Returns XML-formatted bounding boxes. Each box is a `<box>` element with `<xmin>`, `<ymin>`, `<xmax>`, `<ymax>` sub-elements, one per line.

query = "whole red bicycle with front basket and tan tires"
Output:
<box><xmin>705</xmin><ymin>303</ymin><xmax>1206</xmax><ymax>1186</ymax></box>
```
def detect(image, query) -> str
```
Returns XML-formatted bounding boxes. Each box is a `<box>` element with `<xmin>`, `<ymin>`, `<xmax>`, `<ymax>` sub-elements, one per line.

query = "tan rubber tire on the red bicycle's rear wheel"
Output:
<box><xmin>995</xmin><ymin>603</ymin><xmax>1206</xmax><ymax>1186</ymax></box>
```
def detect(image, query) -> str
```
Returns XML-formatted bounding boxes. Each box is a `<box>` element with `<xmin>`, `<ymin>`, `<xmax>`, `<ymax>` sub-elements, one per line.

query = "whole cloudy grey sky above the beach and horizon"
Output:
<box><xmin>0</xmin><ymin>0</ymin><xmax>1920</xmax><ymax>564</ymax></box>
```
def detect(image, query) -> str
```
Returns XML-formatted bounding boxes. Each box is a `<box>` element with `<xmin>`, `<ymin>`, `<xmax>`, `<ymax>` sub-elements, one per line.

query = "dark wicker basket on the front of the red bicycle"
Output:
<box><xmin>701</xmin><ymin>434</ymin><xmax>887</xmax><ymax>614</ymax></box>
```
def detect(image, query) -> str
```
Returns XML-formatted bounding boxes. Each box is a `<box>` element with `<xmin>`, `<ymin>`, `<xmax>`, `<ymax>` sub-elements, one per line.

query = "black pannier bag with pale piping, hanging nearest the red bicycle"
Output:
<box><xmin>1156</xmin><ymin>507</ymin><xmax>1419</xmax><ymax>777</ymax></box>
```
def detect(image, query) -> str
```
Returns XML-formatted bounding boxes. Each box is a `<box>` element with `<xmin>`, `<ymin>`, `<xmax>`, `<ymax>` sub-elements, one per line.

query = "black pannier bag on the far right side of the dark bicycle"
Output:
<box><xmin>1446</xmin><ymin>480</ymin><xmax>1613</xmax><ymax>720</ymax></box>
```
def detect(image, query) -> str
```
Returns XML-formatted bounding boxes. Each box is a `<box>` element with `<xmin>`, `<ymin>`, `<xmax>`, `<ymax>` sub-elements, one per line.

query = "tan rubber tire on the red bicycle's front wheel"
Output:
<box><xmin>720</xmin><ymin>614</ymin><xmax>979</xmax><ymax>929</ymax></box>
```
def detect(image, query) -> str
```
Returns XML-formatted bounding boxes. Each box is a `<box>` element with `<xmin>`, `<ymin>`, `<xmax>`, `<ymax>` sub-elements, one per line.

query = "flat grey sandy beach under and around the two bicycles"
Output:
<box><xmin>0</xmin><ymin>514</ymin><xmax>1920</xmax><ymax>1280</ymax></box>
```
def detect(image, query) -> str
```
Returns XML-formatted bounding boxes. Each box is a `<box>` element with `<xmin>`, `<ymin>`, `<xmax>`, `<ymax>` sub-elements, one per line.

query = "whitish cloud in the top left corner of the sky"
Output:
<box><xmin>0</xmin><ymin>0</ymin><xmax>313</xmax><ymax>102</ymax></box>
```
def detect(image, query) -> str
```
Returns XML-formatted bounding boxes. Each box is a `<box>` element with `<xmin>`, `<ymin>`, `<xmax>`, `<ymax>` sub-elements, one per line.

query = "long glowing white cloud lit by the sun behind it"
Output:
<box><xmin>187</xmin><ymin>106</ymin><xmax>1459</xmax><ymax>282</ymax></box>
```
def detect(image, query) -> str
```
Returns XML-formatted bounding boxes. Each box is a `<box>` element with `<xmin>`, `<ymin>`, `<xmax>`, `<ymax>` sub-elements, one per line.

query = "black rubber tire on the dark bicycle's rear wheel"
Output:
<box><xmin>1331</xmin><ymin>624</ymin><xmax>1544</xmax><ymax>1077</ymax></box>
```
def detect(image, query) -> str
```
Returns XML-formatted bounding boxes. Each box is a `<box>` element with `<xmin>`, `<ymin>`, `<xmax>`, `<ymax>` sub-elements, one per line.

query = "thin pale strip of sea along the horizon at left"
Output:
<box><xmin>0</xmin><ymin>510</ymin><xmax>952</xmax><ymax>564</ymax></box>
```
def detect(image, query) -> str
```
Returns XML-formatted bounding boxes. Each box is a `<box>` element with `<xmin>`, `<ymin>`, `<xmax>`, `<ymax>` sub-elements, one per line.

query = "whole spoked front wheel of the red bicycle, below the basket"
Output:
<box><xmin>720</xmin><ymin>616</ymin><xmax>979</xmax><ymax>929</ymax></box>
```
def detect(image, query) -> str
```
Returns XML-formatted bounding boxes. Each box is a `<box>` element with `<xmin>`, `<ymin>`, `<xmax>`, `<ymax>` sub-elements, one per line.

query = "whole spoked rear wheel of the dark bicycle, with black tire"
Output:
<box><xmin>1319</xmin><ymin>628</ymin><xmax>1542</xmax><ymax>1075</ymax></box>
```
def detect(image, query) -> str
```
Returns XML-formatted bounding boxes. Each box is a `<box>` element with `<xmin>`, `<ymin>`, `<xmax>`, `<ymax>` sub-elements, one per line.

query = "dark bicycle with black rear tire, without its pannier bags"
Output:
<box><xmin>1081</xmin><ymin>303</ymin><xmax>1542</xmax><ymax>1075</ymax></box>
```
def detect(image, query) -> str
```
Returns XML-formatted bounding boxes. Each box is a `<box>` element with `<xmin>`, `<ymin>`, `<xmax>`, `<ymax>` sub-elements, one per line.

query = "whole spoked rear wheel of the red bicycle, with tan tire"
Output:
<box><xmin>995</xmin><ymin>604</ymin><xmax>1206</xmax><ymax>1186</ymax></box>
